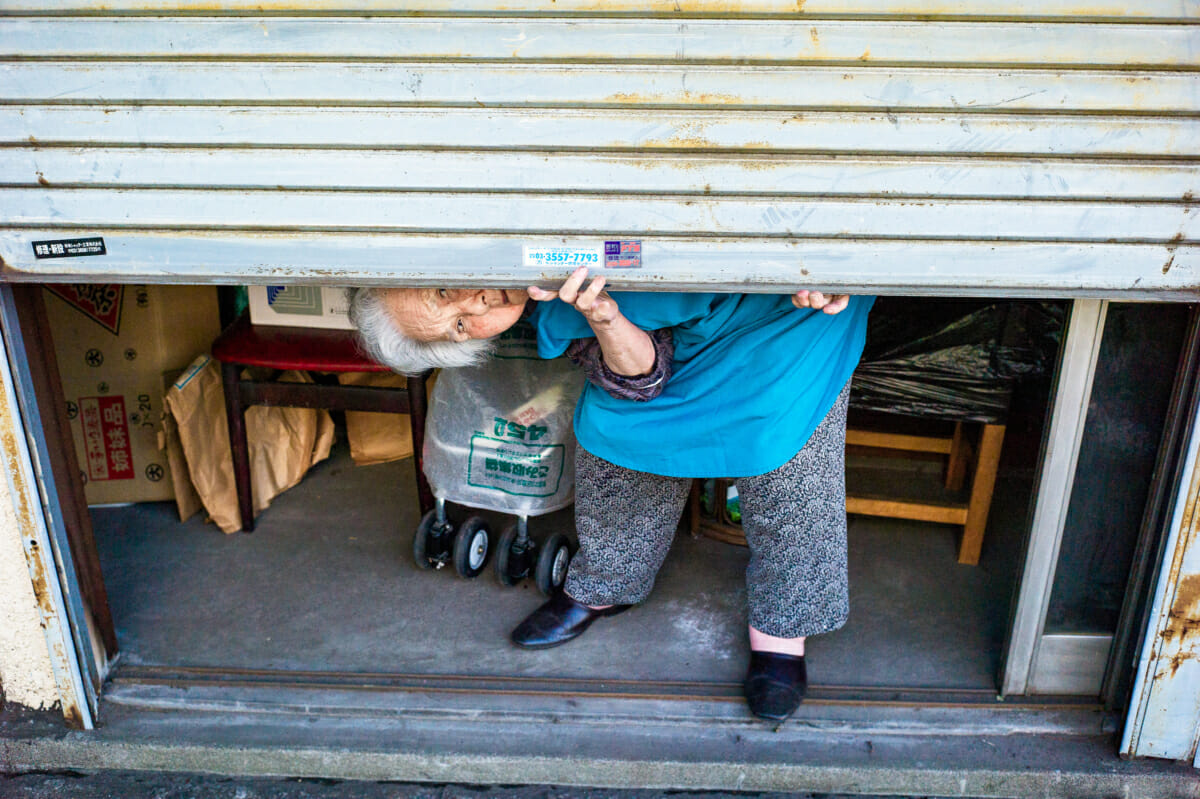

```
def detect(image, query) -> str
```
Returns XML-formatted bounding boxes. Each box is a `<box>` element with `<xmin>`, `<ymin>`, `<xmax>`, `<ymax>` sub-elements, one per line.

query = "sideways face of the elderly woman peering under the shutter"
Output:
<box><xmin>384</xmin><ymin>288</ymin><xmax>529</xmax><ymax>342</ymax></box>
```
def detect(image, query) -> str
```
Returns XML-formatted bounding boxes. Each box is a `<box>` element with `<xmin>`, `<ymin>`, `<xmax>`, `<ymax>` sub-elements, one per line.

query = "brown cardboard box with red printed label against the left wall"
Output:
<box><xmin>46</xmin><ymin>283</ymin><xmax>220</xmax><ymax>505</ymax></box>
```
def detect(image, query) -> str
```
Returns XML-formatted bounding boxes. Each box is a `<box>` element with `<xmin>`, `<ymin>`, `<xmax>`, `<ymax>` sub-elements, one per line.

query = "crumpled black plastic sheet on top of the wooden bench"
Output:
<box><xmin>850</xmin><ymin>298</ymin><xmax>1066</xmax><ymax>423</ymax></box>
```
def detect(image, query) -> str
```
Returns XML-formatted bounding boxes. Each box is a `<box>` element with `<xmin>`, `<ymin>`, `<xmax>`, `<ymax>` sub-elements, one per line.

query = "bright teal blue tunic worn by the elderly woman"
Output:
<box><xmin>530</xmin><ymin>292</ymin><xmax>875</xmax><ymax>477</ymax></box>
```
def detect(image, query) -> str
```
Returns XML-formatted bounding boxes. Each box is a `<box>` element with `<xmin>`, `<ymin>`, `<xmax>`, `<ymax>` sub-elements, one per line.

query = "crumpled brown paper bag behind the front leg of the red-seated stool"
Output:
<box><xmin>167</xmin><ymin>355</ymin><xmax>334</xmax><ymax>533</ymax></box>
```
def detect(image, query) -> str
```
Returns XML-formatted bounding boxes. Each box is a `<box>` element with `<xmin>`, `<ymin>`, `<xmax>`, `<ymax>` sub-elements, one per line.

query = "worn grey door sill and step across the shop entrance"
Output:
<box><xmin>0</xmin><ymin>668</ymin><xmax>1200</xmax><ymax>797</ymax></box>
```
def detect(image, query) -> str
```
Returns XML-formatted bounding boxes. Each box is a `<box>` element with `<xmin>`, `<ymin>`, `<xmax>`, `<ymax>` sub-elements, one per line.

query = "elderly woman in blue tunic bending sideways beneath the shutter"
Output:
<box><xmin>352</xmin><ymin>269</ymin><xmax>872</xmax><ymax>720</ymax></box>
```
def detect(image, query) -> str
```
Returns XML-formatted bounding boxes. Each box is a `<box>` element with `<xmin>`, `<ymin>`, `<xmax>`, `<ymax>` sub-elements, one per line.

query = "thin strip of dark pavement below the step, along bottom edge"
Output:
<box><xmin>0</xmin><ymin>771</ymin><xmax>902</xmax><ymax>799</ymax></box>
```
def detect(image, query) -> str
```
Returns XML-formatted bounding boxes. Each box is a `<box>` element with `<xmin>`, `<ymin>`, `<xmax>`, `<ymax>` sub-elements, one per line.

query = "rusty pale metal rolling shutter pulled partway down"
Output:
<box><xmin>0</xmin><ymin>0</ymin><xmax>1200</xmax><ymax>299</ymax></box>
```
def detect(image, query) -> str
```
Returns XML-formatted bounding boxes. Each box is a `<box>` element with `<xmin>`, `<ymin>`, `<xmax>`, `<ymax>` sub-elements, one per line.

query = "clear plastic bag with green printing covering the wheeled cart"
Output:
<box><xmin>425</xmin><ymin>322</ymin><xmax>584</xmax><ymax>516</ymax></box>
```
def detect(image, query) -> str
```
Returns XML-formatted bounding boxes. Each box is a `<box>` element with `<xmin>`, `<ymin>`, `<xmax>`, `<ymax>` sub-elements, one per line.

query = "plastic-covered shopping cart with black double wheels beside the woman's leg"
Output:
<box><xmin>413</xmin><ymin>322</ymin><xmax>583</xmax><ymax>595</ymax></box>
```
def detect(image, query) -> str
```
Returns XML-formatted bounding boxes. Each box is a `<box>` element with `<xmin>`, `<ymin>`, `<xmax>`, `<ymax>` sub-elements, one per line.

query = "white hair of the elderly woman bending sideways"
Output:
<box><xmin>350</xmin><ymin>288</ymin><xmax>492</xmax><ymax>374</ymax></box>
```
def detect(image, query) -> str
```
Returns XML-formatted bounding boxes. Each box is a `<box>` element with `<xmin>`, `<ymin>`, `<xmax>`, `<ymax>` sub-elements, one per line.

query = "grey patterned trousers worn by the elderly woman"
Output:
<box><xmin>566</xmin><ymin>383</ymin><xmax>850</xmax><ymax>638</ymax></box>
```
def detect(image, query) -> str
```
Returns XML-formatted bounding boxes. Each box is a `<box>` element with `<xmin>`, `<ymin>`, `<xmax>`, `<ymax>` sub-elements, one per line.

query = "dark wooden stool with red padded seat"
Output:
<box><xmin>212</xmin><ymin>314</ymin><xmax>433</xmax><ymax>533</ymax></box>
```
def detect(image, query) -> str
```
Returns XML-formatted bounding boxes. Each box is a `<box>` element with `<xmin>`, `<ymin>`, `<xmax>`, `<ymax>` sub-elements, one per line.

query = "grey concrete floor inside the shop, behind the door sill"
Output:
<box><xmin>92</xmin><ymin>436</ymin><xmax>1030</xmax><ymax>690</ymax></box>
